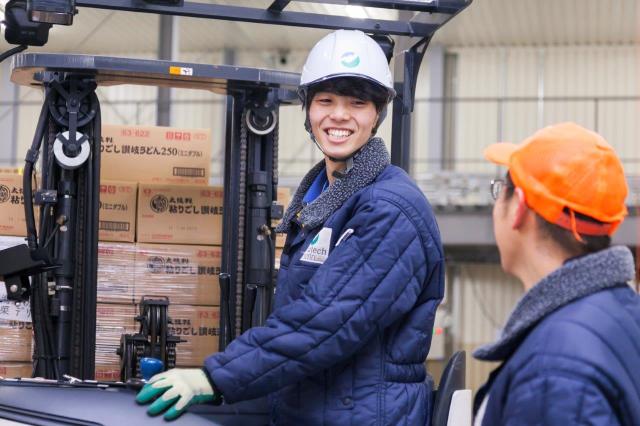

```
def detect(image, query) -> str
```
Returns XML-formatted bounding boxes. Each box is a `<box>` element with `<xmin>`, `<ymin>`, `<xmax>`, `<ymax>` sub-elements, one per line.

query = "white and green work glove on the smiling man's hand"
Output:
<box><xmin>136</xmin><ymin>368</ymin><xmax>220</xmax><ymax>420</ymax></box>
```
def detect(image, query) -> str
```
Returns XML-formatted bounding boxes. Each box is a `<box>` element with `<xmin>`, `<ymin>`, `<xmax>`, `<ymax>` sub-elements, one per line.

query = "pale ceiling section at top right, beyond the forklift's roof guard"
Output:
<box><xmin>436</xmin><ymin>0</ymin><xmax>640</xmax><ymax>46</ymax></box>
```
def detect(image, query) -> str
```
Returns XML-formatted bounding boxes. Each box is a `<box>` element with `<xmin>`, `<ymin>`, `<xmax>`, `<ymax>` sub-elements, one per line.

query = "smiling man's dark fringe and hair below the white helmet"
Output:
<box><xmin>305</xmin><ymin>77</ymin><xmax>389</xmax><ymax>113</ymax></box>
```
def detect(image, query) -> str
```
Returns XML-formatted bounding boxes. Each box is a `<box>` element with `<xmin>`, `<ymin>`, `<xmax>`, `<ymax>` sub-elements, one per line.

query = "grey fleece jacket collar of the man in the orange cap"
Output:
<box><xmin>473</xmin><ymin>246</ymin><xmax>635</xmax><ymax>361</ymax></box>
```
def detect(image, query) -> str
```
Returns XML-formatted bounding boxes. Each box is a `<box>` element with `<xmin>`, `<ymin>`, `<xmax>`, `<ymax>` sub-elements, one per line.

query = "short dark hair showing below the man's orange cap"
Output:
<box><xmin>504</xmin><ymin>173</ymin><xmax>611</xmax><ymax>256</ymax></box>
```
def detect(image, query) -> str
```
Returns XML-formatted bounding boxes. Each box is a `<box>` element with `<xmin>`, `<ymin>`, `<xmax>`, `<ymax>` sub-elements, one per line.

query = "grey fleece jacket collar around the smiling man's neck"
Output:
<box><xmin>276</xmin><ymin>138</ymin><xmax>389</xmax><ymax>232</ymax></box>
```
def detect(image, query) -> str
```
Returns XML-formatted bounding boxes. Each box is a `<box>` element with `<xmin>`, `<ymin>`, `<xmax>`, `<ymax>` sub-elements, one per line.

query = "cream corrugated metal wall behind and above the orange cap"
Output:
<box><xmin>450</xmin><ymin>45</ymin><xmax>640</xmax><ymax>174</ymax></box>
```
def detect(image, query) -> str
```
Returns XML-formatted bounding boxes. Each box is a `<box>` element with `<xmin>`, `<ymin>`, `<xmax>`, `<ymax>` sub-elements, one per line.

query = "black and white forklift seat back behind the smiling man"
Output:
<box><xmin>431</xmin><ymin>351</ymin><xmax>472</xmax><ymax>426</ymax></box>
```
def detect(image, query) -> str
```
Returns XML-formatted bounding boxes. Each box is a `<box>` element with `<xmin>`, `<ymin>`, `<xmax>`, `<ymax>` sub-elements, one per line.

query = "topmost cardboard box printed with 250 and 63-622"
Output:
<box><xmin>100</xmin><ymin>125</ymin><xmax>211</xmax><ymax>185</ymax></box>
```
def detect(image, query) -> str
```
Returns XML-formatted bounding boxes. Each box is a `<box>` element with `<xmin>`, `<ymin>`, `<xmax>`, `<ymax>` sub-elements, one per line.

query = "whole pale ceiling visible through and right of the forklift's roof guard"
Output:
<box><xmin>0</xmin><ymin>0</ymin><xmax>640</xmax><ymax>54</ymax></box>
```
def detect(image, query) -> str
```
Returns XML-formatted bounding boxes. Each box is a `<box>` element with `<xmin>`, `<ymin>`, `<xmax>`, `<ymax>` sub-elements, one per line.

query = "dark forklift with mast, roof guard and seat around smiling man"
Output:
<box><xmin>0</xmin><ymin>0</ymin><xmax>471</xmax><ymax>426</ymax></box>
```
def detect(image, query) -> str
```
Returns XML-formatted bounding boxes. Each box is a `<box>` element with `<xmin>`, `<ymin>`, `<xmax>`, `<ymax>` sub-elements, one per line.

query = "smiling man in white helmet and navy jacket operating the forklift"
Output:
<box><xmin>138</xmin><ymin>30</ymin><xmax>444</xmax><ymax>426</ymax></box>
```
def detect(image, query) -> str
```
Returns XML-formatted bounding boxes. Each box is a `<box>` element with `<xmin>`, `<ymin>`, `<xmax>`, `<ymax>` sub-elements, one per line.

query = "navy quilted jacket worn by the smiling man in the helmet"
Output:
<box><xmin>206</xmin><ymin>139</ymin><xmax>444</xmax><ymax>426</ymax></box>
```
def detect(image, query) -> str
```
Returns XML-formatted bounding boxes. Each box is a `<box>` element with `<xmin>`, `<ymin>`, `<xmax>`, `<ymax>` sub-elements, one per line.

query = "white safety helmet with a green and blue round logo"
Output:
<box><xmin>298</xmin><ymin>30</ymin><xmax>396</xmax><ymax>105</ymax></box>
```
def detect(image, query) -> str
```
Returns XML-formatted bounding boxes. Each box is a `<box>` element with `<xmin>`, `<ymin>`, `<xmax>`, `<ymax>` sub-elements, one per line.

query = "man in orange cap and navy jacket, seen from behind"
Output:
<box><xmin>474</xmin><ymin>123</ymin><xmax>640</xmax><ymax>426</ymax></box>
